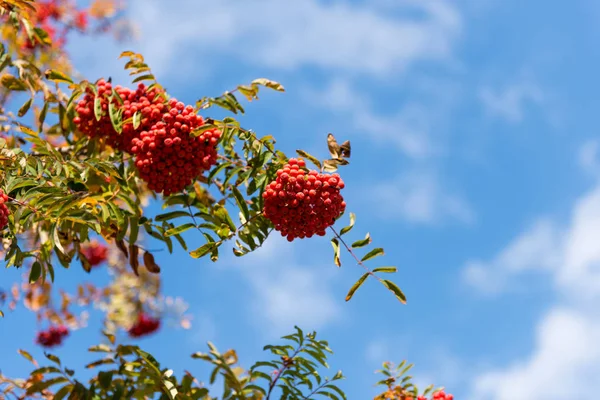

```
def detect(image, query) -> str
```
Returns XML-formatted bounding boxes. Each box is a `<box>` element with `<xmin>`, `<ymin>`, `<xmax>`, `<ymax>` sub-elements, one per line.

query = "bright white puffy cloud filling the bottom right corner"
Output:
<box><xmin>470</xmin><ymin>308</ymin><xmax>600</xmax><ymax>400</ymax></box>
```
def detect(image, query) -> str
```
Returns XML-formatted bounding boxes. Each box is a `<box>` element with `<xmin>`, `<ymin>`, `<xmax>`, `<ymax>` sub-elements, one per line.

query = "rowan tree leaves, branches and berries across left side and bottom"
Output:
<box><xmin>0</xmin><ymin>0</ymin><xmax>452</xmax><ymax>400</ymax></box>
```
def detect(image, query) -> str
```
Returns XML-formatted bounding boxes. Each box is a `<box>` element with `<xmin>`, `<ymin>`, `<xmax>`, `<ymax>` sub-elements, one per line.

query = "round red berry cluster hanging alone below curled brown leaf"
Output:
<box><xmin>263</xmin><ymin>158</ymin><xmax>346</xmax><ymax>242</ymax></box>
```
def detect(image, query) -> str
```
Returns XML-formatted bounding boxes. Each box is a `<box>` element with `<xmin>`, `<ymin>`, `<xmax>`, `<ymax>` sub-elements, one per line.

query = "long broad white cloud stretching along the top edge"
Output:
<box><xmin>126</xmin><ymin>0</ymin><xmax>461</xmax><ymax>79</ymax></box>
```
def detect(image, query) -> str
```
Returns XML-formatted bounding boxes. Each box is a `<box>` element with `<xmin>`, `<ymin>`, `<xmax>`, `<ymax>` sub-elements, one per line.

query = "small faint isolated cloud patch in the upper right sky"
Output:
<box><xmin>479</xmin><ymin>82</ymin><xmax>544</xmax><ymax>123</ymax></box>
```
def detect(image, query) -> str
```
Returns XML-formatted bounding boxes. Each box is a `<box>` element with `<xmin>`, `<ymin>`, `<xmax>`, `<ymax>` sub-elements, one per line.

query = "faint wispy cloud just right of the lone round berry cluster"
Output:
<box><xmin>369</xmin><ymin>171</ymin><xmax>475</xmax><ymax>224</ymax></box>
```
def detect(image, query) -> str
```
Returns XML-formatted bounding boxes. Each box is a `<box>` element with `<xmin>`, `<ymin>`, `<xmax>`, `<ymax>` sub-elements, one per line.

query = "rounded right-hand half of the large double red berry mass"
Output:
<box><xmin>131</xmin><ymin>99</ymin><xmax>221</xmax><ymax>195</ymax></box>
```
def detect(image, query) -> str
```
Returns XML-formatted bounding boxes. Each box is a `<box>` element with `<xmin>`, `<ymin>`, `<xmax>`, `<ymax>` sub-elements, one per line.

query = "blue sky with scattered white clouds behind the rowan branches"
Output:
<box><xmin>0</xmin><ymin>0</ymin><xmax>600</xmax><ymax>400</ymax></box>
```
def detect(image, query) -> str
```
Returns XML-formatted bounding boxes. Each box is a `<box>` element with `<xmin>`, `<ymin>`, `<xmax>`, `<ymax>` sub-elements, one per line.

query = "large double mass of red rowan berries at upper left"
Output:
<box><xmin>73</xmin><ymin>80</ymin><xmax>221</xmax><ymax>195</ymax></box>
